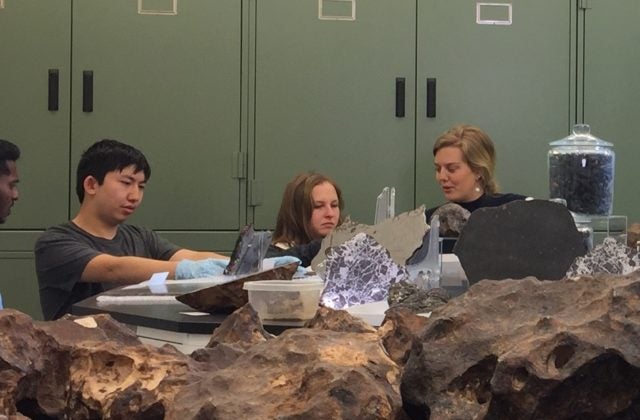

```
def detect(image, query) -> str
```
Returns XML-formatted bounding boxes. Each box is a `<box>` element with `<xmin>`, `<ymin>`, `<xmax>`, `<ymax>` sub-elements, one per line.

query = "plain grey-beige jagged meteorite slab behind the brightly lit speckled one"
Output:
<box><xmin>311</xmin><ymin>206</ymin><xmax>429</xmax><ymax>275</ymax></box>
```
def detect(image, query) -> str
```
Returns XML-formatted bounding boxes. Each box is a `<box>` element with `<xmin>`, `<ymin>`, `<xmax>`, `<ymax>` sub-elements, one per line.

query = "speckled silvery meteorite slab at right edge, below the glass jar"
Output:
<box><xmin>567</xmin><ymin>238</ymin><xmax>640</xmax><ymax>278</ymax></box>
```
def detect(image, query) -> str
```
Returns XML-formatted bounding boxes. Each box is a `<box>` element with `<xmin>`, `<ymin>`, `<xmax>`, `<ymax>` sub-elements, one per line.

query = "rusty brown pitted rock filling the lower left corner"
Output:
<box><xmin>0</xmin><ymin>310</ymin><xmax>205</xmax><ymax>419</ymax></box>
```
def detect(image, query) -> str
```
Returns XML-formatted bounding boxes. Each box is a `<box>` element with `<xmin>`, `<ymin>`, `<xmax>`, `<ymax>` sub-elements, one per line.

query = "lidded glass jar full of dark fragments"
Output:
<box><xmin>548</xmin><ymin>124</ymin><xmax>615</xmax><ymax>216</ymax></box>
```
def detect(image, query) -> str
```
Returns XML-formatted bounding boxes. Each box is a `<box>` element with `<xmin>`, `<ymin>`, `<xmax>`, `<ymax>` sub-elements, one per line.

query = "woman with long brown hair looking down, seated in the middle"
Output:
<box><xmin>267</xmin><ymin>172</ymin><xmax>344</xmax><ymax>267</ymax></box>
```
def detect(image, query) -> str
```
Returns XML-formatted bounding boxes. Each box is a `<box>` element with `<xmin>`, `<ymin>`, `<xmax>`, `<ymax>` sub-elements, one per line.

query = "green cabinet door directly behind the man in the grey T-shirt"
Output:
<box><xmin>71</xmin><ymin>0</ymin><xmax>241</xmax><ymax>231</ymax></box>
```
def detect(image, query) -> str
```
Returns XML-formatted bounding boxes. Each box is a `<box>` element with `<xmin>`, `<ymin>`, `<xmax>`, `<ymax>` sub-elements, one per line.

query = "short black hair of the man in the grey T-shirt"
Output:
<box><xmin>76</xmin><ymin>139</ymin><xmax>151</xmax><ymax>203</ymax></box>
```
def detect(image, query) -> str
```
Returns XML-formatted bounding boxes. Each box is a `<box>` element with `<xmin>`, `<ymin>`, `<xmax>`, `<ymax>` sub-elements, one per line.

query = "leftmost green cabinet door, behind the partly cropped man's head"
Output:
<box><xmin>0</xmin><ymin>0</ymin><xmax>71</xmax><ymax>230</ymax></box>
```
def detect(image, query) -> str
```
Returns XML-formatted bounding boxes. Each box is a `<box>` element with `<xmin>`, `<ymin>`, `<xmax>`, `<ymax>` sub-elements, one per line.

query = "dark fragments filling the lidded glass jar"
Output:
<box><xmin>549</xmin><ymin>152</ymin><xmax>614</xmax><ymax>216</ymax></box>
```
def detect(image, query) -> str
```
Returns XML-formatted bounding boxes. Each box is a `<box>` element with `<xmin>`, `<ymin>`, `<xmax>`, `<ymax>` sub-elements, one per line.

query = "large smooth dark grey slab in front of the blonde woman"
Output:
<box><xmin>453</xmin><ymin>200</ymin><xmax>586</xmax><ymax>284</ymax></box>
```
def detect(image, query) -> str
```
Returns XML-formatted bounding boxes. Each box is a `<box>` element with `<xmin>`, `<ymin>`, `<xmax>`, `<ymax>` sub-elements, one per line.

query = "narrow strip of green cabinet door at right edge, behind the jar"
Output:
<box><xmin>583</xmin><ymin>0</ymin><xmax>640</xmax><ymax>223</ymax></box>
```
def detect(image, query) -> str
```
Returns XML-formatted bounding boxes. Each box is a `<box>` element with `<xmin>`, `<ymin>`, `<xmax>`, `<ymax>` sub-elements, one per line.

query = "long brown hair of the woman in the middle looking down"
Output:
<box><xmin>273</xmin><ymin>172</ymin><xmax>344</xmax><ymax>246</ymax></box>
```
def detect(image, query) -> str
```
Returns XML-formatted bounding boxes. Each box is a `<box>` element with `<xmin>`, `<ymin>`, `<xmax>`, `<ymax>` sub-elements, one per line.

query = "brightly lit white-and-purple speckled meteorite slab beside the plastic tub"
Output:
<box><xmin>320</xmin><ymin>233</ymin><xmax>409</xmax><ymax>309</ymax></box>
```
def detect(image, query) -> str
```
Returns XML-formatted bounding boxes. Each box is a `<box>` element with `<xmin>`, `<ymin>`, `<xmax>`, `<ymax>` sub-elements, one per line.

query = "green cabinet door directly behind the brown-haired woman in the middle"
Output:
<box><xmin>250</xmin><ymin>0</ymin><xmax>415</xmax><ymax>228</ymax></box>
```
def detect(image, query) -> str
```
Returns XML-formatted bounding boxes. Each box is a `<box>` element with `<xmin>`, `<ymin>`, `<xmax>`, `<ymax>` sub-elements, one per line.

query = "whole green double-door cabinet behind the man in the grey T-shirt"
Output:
<box><xmin>0</xmin><ymin>0</ymin><xmax>246</xmax><ymax>318</ymax></box>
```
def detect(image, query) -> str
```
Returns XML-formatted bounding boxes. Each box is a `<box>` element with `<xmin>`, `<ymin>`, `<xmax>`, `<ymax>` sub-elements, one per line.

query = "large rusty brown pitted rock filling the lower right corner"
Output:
<box><xmin>401</xmin><ymin>273</ymin><xmax>640</xmax><ymax>419</ymax></box>
